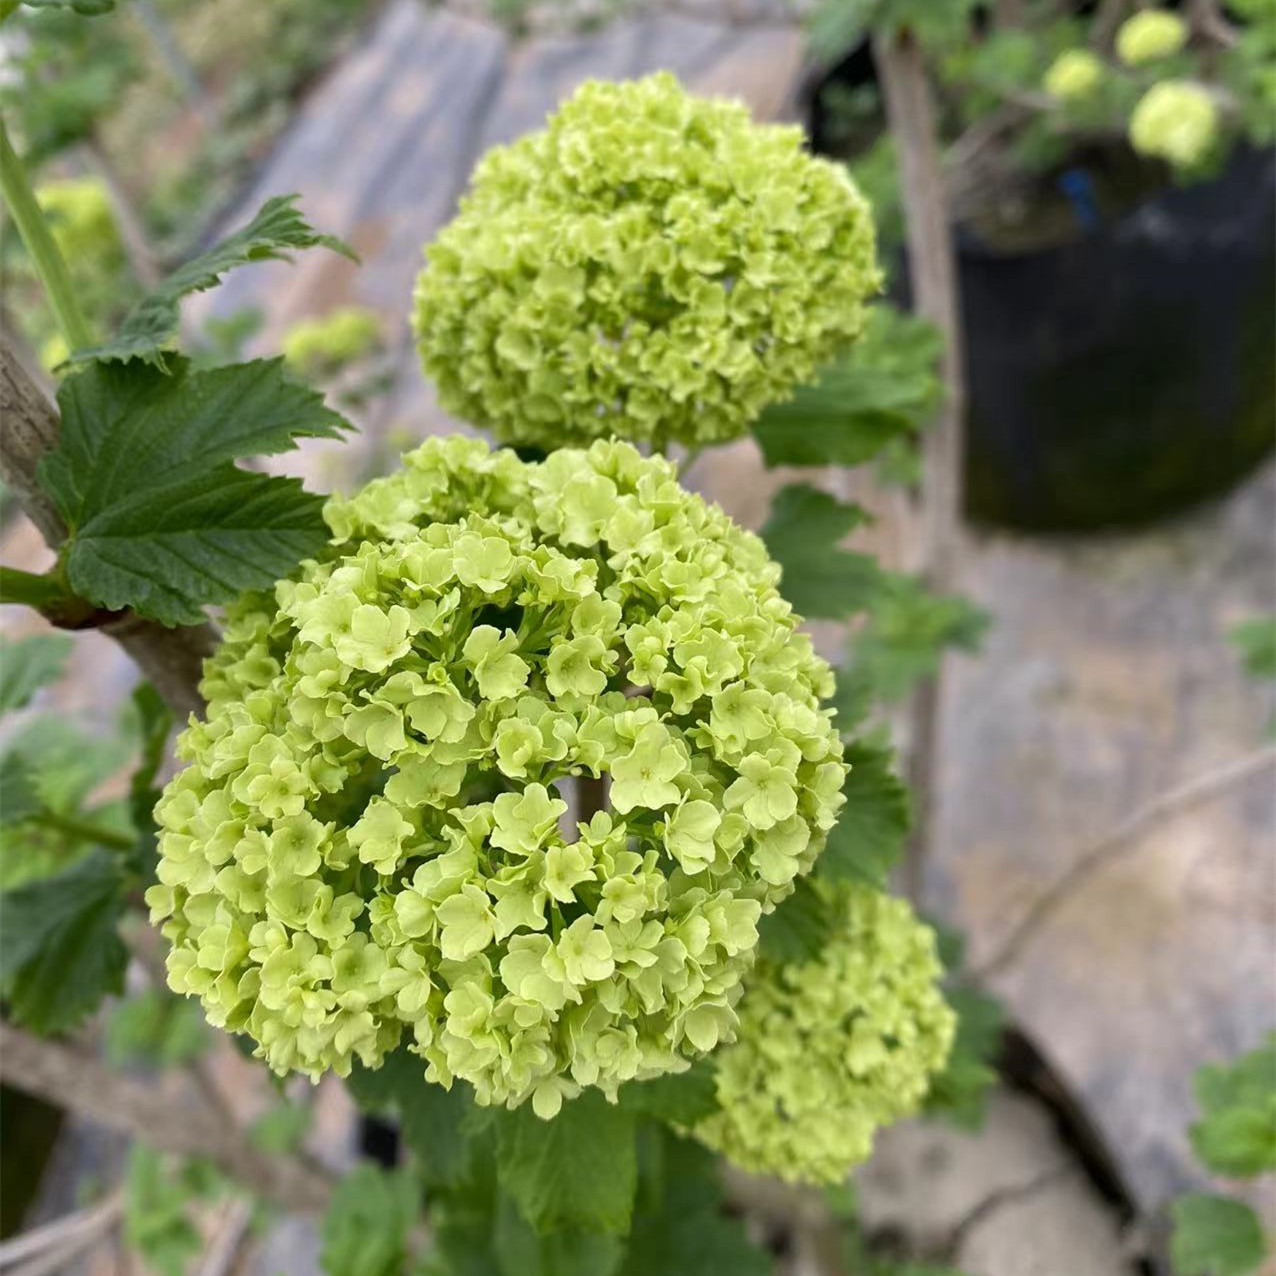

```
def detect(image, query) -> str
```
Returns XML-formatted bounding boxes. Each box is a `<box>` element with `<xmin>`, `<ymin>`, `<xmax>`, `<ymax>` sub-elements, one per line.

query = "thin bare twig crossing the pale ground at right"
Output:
<box><xmin>971</xmin><ymin>745</ymin><xmax>1276</xmax><ymax>980</ymax></box>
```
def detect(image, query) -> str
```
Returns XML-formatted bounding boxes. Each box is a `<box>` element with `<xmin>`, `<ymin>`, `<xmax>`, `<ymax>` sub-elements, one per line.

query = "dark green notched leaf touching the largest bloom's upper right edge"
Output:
<box><xmin>762</xmin><ymin>484</ymin><xmax>882</xmax><ymax>620</ymax></box>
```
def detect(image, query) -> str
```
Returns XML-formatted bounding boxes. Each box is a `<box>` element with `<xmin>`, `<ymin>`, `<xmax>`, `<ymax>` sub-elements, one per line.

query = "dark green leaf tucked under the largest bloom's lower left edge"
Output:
<box><xmin>346</xmin><ymin>1046</ymin><xmax>475</xmax><ymax>1184</ymax></box>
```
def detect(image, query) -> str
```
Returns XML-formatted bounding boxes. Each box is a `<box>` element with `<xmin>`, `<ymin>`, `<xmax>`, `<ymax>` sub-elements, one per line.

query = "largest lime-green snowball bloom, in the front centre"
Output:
<box><xmin>148</xmin><ymin>438</ymin><xmax>846</xmax><ymax>1115</ymax></box>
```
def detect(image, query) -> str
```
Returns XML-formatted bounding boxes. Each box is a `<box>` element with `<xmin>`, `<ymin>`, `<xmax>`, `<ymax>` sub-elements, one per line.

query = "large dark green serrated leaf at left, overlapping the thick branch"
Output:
<box><xmin>41</xmin><ymin>360</ymin><xmax>346</xmax><ymax>625</ymax></box>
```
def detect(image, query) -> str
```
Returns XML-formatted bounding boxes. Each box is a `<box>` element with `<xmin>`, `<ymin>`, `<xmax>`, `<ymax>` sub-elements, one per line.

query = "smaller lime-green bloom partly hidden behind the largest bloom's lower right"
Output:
<box><xmin>694</xmin><ymin>883</ymin><xmax>956</xmax><ymax>1183</ymax></box>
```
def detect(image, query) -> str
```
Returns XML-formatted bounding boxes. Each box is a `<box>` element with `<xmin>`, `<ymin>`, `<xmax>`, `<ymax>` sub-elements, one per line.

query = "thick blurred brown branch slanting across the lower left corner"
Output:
<box><xmin>0</xmin><ymin>1023</ymin><xmax>329</xmax><ymax>1211</ymax></box>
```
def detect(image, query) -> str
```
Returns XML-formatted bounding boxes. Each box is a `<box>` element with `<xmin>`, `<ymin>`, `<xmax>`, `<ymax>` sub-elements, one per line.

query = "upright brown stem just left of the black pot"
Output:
<box><xmin>873</xmin><ymin>31</ymin><xmax>966</xmax><ymax>898</ymax></box>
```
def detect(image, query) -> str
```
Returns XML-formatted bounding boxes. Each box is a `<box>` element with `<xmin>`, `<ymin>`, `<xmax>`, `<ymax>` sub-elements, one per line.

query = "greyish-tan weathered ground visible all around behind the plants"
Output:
<box><xmin>5</xmin><ymin>0</ymin><xmax>1276</xmax><ymax>1276</ymax></box>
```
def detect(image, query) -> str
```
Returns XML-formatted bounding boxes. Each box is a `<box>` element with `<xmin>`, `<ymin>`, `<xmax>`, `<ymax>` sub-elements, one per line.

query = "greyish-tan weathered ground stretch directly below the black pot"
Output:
<box><xmin>929</xmin><ymin>468</ymin><xmax>1276</xmax><ymax>1213</ymax></box>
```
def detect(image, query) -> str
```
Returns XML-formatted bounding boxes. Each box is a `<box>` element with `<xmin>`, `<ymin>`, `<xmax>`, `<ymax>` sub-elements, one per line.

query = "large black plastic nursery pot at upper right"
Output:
<box><xmin>810</xmin><ymin>72</ymin><xmax>1276</xmax><ymax>532</ymax></box>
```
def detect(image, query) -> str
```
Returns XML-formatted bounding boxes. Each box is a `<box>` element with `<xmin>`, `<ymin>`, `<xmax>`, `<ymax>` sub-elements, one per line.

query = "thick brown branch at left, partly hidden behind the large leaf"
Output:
<box><xmin>0</xmin><ymin>332</ymin><xmax>217</xmax><ymax>720</ymax></box>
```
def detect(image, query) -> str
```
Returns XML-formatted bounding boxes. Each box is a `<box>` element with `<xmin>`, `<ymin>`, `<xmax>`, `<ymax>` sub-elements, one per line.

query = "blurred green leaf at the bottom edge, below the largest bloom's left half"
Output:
<box><xmin>319</xmin><ymin>1162</ymin><xmax>421</xmax><ymax>1276</ymax></box>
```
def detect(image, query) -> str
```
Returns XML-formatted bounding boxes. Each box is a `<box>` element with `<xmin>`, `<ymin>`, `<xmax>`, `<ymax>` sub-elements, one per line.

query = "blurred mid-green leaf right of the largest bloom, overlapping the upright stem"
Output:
<box><xmin>842</xmin><ymin>572</ymin><xmax>989</xmax><ymax>703</ymax></box>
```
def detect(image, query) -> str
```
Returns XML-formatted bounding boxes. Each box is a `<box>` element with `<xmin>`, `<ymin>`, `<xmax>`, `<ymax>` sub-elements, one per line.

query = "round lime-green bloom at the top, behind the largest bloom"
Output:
<box><xmin>415</xmin><ymin>73</ymin><xmax>879</xmax><ymax>448</ymax></box>
